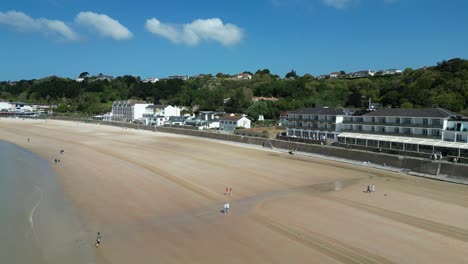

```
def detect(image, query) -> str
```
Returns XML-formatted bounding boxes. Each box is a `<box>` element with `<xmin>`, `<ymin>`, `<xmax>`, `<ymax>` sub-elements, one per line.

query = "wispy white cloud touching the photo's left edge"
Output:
<box><xmin>0</xmin><ymin>11</ymin><xmax>78</xmax><ymax>40</ymax></box>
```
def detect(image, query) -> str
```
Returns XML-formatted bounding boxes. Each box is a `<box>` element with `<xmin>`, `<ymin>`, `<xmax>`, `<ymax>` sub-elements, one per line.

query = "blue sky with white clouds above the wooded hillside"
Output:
<box><xmin>0</xmin><ymin>0</ymin><xmax>468</xmax><ymax>81</ymax></box>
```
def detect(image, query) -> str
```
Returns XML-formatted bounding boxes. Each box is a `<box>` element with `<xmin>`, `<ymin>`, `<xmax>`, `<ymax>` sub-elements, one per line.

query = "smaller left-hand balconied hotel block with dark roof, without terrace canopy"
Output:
<box><xmin>286</xmin><ymin>107</ymin><xmax>352</xmax><ymax>140</ymax></box>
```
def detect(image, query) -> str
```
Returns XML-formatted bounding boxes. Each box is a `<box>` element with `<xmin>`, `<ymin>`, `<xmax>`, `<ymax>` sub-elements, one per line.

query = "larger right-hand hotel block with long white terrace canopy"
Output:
<box><xmin>338</xmin><ymin>108</ymin><xmax>468</xmax><ymax>161</ymax></box>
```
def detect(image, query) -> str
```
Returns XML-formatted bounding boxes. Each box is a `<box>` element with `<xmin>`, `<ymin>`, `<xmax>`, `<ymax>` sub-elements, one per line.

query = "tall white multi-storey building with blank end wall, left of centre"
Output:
<box><xmin>112</xmin><ymin>100</ymin><xmax>150</xmax><ymax>122</ymax></box>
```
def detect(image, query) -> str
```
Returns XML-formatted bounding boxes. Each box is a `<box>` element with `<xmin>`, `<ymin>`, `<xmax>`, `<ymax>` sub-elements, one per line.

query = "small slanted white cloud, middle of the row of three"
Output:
<box><xmin>75</xmin><ymin>12</ymin><xmax>133</xmax><ymax>40</ymax></box>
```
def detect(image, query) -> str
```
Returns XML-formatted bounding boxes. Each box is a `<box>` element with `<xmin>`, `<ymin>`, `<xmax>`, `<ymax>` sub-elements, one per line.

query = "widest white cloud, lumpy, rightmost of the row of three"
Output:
<box><xmin>145</xmin><ymin>18</ymin><xmax>243</xmax><ymax>46</ymax></box>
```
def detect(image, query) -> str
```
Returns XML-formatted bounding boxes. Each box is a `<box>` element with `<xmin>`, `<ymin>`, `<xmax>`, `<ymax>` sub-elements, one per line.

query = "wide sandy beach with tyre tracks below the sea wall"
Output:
<box><xmin>0</xmin><ymin>119</ymin><xmax>468</xmax><ymax>263</ymax></box>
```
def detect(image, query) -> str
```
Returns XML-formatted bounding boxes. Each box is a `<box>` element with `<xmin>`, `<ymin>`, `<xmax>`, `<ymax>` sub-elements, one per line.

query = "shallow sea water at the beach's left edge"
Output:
<box><xmin>0</xmin><ymin>141</ymin><xmax>94</xmax><ymax>264</ymax></box>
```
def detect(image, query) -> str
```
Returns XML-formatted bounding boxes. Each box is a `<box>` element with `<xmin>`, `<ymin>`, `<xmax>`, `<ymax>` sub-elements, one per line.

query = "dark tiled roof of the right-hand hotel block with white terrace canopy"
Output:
<box><xmin>363</xmin><ymin>108</ymin><xmax>461</xmax><ymax>118</ymax></box>
